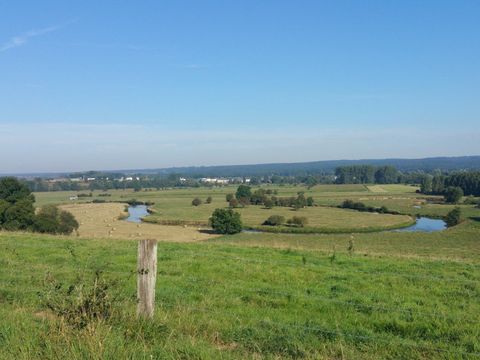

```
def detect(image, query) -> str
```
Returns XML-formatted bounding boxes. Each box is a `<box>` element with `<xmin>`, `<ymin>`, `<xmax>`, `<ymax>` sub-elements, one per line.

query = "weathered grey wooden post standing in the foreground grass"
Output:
<box><xmin>137</xmin><ymin>240</ymin><xmax>157</xmax><ymax>318</ymax></box>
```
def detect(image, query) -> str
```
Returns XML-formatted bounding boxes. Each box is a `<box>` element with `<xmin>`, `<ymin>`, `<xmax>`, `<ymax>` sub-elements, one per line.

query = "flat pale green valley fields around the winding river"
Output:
<box><xmin>31</xmin><ymin>184</ymin><xmax>480</xmax><ymax>232</ymax></box>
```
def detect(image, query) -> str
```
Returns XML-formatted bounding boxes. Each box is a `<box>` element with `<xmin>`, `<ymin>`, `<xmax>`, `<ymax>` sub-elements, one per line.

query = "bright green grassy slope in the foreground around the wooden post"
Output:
<box><xmin>0</xmin><ymin>224</ymin><xmax>480</xmax><ymax>359</ymax></box>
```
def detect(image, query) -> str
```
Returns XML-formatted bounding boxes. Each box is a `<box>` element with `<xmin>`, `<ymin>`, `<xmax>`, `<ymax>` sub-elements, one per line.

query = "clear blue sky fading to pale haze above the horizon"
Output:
<box><xmin>0</xmin><ymin>0</ymin><xmax>480</xmax><ymax>173</ymax></box>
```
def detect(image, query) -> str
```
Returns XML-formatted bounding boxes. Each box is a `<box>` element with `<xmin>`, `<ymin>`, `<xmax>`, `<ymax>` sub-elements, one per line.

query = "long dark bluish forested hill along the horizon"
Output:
<box><xmin>152</xmin><ymin>156</ymin><xmax>480</xmax><ymax>177</ymax></box>
